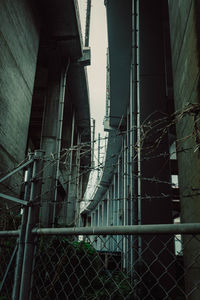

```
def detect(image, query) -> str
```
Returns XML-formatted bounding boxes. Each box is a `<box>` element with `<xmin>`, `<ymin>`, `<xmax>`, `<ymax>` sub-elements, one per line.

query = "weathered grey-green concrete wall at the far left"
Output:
<box><xmin>0</xmin><ymin>0</ymin><xmax>39</xmax><ymax>196</ymax></box>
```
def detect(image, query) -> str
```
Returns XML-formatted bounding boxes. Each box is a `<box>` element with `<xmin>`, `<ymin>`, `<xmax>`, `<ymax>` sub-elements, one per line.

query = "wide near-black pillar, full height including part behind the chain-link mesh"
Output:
<box><xmin>138</xmin><ymin>0</ymin><xmax>175</xmax><ymax>299</ymax></box>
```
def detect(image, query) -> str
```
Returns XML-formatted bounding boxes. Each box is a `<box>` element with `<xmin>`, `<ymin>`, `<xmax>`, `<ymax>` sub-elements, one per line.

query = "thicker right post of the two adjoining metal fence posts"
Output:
<box><xmin>19</xmin><ymin>150</ymin><xmax>44</xmax><ymax>300</ymax></box>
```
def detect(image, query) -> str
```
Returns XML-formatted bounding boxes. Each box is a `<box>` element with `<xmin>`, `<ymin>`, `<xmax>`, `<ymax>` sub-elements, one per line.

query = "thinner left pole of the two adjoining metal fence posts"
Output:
<box><xmin>12</xmin><ymin>153</ymin><xmax>33</xmax><ymax>300</ymax></box>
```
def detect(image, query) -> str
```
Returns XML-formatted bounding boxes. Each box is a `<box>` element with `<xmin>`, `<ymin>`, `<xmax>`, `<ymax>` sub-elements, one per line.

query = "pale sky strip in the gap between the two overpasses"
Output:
<box><xmin>78</xmin><ymin>0</ymin><xmax>107</xmax><ymax>137</ymax></box>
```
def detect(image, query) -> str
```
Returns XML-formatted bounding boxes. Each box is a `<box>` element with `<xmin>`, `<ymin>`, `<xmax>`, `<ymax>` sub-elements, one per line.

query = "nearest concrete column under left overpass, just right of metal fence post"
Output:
<box><xmin>40</xmin><ymin>51</ymin><xmax>61</xmax><ymax>227</ymax></box>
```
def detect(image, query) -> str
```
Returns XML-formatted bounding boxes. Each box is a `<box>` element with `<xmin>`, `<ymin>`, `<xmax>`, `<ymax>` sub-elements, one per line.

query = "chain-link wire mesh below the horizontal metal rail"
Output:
<box><xmin>0</xmin><ymin>225</ymin><xmax>200</xmax><ymax>300</ymax></box>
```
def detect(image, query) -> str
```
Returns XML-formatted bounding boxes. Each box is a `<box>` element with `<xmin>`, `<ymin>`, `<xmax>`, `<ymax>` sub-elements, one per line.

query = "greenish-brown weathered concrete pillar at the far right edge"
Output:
<box><xmin>168</xmin><ymin>0</ymin><xmax>200</xmax><ymax>300</ymax></box>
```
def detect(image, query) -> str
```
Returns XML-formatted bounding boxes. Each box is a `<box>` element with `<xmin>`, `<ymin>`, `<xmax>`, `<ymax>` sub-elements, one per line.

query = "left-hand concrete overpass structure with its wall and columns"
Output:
<box><xmin>0</xmin><ymin>0</ymin><xmax>91</xmax><ymax>226</ymax></box>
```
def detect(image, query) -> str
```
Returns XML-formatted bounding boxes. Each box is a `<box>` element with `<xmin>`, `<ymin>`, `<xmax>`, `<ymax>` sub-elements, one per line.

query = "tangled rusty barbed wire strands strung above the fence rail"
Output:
<box><xmin>0</xmin><ymin>104</ymin><xmax>200</xmax><ymax>223</ymax></box>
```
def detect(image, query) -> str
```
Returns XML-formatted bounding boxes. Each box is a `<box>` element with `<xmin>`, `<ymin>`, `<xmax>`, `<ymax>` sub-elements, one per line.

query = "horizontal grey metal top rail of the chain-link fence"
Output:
<box><xmin>0</xmin><ymin>223</ymin><xmax>200</xmax><ymax>238</ymax></box>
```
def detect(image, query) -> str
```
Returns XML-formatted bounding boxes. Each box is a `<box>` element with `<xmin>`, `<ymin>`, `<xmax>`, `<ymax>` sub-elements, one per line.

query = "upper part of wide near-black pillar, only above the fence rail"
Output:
<box><xmin>139</xmin><ymin>0</ymin><xmax>172</xmax><ymax>224</ymax></box>
